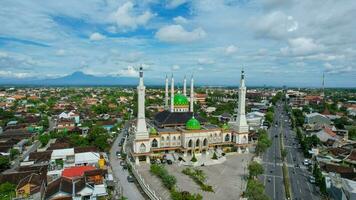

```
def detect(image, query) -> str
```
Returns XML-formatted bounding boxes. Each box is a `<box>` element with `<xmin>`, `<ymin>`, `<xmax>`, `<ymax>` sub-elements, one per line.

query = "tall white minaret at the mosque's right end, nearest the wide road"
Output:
<box><xmin>236</xmin><ymin>70</ymin><xmax>248</xmax><ymax>133</ymax></box>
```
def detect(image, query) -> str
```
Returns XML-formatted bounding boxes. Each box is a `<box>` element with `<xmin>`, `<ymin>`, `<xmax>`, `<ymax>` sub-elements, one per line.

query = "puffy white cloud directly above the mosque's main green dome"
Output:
<box><xmin>155</xmin><ymin>25</ymin><xmax>206</xmax><ymax>43</ymax></box>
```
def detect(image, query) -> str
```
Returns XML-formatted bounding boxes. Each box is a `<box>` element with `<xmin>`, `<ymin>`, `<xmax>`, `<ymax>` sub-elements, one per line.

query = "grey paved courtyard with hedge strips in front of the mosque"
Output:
<box><xmin>138</xmin><ymin>154</ymin><xmax>252</xmax><ymax>200</ymax></box>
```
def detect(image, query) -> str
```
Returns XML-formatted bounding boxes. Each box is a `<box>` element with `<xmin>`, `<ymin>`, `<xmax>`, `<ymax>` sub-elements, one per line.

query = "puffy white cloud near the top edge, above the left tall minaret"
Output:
<box><xmin>112</xmin><ymin>1</ymin><xmax>154</xmax><ymax>30</ymax></box>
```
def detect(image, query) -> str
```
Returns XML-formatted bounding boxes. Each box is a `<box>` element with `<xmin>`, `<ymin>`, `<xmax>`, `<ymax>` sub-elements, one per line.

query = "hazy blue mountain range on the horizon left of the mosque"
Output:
<box><xmin>0</xmin><ymin>71</ymin><xmax>138</xmax><ymax>86</ymax></box>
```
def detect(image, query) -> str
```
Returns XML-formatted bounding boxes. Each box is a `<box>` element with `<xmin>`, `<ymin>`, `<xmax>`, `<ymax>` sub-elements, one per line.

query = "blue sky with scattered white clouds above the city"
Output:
<box><xmin>0</xmin><ymin>0</ymin><xmax>356</xmax><ymax>87</ymax></box>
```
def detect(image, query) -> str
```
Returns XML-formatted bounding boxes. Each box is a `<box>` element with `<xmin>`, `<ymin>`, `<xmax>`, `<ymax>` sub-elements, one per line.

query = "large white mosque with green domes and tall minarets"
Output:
<box><xmin>132</xmin><ymin>68</ymin><xmax>249</xmax><ymax>164</ymax></box>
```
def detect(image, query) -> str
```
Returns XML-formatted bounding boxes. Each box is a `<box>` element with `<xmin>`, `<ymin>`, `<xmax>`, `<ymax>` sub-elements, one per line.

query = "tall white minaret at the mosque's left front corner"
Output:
<box><xmin>135</xmin><ymin>67</ymin><xmax>149</xmax><ymax>139</ymax></box>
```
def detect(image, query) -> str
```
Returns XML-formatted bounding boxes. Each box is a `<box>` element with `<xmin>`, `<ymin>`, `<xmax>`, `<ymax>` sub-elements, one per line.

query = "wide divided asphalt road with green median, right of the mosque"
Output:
<box><xmin>262</xmin><ymin>104</ymin><xmax>320</xmax><ymax>200</ymax></box>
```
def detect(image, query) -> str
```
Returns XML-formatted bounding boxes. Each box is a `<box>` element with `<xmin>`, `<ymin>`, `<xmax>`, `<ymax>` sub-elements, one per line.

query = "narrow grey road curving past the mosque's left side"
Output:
<box><xmin>110</xmin><ymin>123</ymin><xmax>145</xmax><ymax>200</ymax></box>
